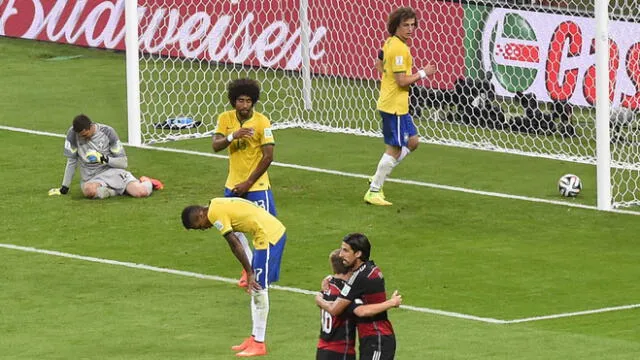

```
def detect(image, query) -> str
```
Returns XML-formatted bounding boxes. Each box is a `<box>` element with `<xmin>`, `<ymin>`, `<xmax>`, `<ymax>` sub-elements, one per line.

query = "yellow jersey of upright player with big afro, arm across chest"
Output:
<box><xmin>215</xmin><ymin>110</ymin><xmax>275</xmax><ymax>191</ymax></box>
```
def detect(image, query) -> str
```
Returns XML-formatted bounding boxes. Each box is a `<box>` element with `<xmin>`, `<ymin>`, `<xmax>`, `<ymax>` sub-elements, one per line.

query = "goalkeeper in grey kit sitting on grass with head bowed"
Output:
<box><xmin>49</xmin><ymin>115</ymin><xmax>164</xmax><ymax>199</ymax></box>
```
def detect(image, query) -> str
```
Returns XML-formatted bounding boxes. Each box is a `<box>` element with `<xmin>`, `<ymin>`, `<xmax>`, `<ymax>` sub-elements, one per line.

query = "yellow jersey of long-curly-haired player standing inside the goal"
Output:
<box><xmin>378</xmin><ymin>36</ymin><xmax>413</xmax><ymax>115</ymax></box>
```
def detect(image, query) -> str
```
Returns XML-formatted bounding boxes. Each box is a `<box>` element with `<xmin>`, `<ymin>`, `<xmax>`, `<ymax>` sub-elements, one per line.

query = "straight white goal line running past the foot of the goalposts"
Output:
<box><xmin>0</xmin><ymin>125</ymin><xmax>640</xmax><ymax>216</ymax></box>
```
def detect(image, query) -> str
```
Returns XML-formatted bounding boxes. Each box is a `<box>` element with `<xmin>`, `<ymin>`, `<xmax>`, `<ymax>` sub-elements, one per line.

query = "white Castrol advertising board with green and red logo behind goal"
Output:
<box><xmin>479</xmin><ymin>8</ymin><xmax>640</xmax><ymax>109</ymax></box>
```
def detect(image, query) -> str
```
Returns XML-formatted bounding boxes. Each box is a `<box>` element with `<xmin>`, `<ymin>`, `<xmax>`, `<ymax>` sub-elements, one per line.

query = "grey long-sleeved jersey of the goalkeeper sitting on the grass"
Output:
<box><xmin>64</xmin><ymin>123</ymin><xmax>127</xmax><ymax>182</ymax></box>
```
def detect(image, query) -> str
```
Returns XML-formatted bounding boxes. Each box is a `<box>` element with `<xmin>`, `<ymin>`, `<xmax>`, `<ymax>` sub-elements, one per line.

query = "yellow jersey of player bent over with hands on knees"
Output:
<box><xmin>207</xmin><ymin>198</ymin><xmax>286</xmax><ymax>250</ymax></box>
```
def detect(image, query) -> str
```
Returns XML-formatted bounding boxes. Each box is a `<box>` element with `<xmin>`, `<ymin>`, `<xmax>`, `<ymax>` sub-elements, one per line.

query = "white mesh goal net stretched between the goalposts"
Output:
<box><xmin>139</xmin><ymin>0</ymin><xmax>640</xmax><ymax>205</ymax></box>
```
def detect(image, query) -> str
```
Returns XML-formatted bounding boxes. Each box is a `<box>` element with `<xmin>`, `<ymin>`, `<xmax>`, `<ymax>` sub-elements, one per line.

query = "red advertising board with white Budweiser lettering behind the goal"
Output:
<box><xmin>0</xmin><ymin>0</ymin><xmax>464</xmax><ymax>87</ymax></box>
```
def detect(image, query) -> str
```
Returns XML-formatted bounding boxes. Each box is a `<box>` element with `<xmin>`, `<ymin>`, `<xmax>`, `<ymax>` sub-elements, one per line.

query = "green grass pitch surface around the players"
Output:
<box><xmin>0</xmin><ymin>38</ymin><xmax>640</xmax><ymax>360</ymax></box>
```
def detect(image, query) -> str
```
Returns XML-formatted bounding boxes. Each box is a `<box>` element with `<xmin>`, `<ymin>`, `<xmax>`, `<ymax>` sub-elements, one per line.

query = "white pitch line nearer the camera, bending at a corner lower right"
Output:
<box><xmin>0</xmin><ymin>243</ymin><xmax>640</xmax><ymax>324</ymax></box>
